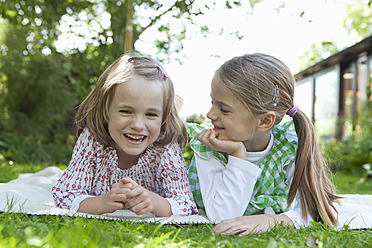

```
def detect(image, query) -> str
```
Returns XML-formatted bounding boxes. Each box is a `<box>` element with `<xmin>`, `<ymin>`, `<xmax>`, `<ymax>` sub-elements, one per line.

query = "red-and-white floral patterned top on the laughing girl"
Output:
<box><xmin>52</xmin><ymin>128</ymin><xmax>198</xmax><ymax>215</ymax></box>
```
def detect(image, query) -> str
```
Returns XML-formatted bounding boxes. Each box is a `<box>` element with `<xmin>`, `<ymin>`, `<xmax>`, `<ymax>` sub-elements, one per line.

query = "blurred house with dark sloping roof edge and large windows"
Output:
<box><xmin>294</xmin><ymin>36</ymin><xmax>372</xmax><ymax>141</ymax></box>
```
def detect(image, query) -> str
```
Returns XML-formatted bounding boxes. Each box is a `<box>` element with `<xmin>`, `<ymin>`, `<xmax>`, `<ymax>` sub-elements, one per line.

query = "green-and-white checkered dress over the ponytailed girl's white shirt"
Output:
<box><xmin>186</xmin><ymin>120</ymin><xmax>297</xmax><ymax>215</ymax></box>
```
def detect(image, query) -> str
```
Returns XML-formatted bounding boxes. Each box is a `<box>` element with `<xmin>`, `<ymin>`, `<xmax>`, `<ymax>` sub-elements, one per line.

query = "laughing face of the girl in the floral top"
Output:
<box><xmin>108</xmin><ymin>76</ymin><xmax>164</xmax><ymax>160</ymax></box>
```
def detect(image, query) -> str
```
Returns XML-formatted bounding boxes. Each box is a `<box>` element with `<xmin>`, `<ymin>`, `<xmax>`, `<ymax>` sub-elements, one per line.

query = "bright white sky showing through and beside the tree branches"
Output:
<box><xmin>56</xmin><ymin>0</ymin><xmax>356</xmax><ymax>118</ymax></box>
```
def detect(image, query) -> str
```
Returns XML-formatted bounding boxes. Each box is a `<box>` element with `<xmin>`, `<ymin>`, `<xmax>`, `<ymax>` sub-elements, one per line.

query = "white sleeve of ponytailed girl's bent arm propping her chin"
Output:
<box><xmin>195</xmin><ymin>156</ymin><xmax>262</xmax><ymax>222</ymax></box>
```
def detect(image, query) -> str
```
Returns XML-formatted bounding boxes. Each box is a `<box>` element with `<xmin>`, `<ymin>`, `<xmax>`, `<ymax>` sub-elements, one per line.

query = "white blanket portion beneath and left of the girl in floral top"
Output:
<box><xmin>0</xmin><ymin>166</ymin><xmax>211</xmax><ymax>224</ymax></box>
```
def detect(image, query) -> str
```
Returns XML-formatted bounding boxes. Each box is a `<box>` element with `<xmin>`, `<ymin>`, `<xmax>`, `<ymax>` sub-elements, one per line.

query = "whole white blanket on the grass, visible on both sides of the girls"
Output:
<box><xmin>0</xmin><ymin>167</ymin><xmax>372</xmax><ymax>229</ymax></box>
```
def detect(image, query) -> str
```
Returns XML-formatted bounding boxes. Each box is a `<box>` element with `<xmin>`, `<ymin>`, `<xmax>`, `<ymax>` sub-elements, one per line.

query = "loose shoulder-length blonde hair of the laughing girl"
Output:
<box><xmin>75</xmin><ymin>54</ymin><xmax>187</xmax><ymax>148</ymax></box>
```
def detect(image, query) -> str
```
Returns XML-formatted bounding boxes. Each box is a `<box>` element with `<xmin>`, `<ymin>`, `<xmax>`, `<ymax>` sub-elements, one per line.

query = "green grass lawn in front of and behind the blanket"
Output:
<box><xmin>0</xmin><ymin>164</ymin><xmax>372</xmax><ymax>248</ymax></box>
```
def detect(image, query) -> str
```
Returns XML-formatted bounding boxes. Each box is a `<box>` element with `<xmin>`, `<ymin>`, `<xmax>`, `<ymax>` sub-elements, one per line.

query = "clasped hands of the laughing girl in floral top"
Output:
<box><xmin>105</xmin><ymin>177</ymin><xmax>153</xmax><ymax>215</ymax></box>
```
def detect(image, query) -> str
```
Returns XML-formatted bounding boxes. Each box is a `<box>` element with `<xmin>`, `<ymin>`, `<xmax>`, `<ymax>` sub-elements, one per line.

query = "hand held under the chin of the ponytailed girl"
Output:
<box><xmin>198</xmin><ymin>129</ymin><xmax>246</xmax><ymax>159</ymax></box>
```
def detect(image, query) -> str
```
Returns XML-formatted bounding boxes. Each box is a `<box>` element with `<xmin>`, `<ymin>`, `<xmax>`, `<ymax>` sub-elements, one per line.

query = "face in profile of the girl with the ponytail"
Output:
<box><xmin>207</xmin><ymin>75</ymin><xmax>258</xmax><ymax>144</ymax></box>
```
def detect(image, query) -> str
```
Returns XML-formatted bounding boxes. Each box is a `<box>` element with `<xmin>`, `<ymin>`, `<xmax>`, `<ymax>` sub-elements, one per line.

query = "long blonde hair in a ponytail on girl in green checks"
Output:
<box><xmin>216</xmin><ymin>54</ymin><xmax>340</xmax><ymax>226</ymax></box>
